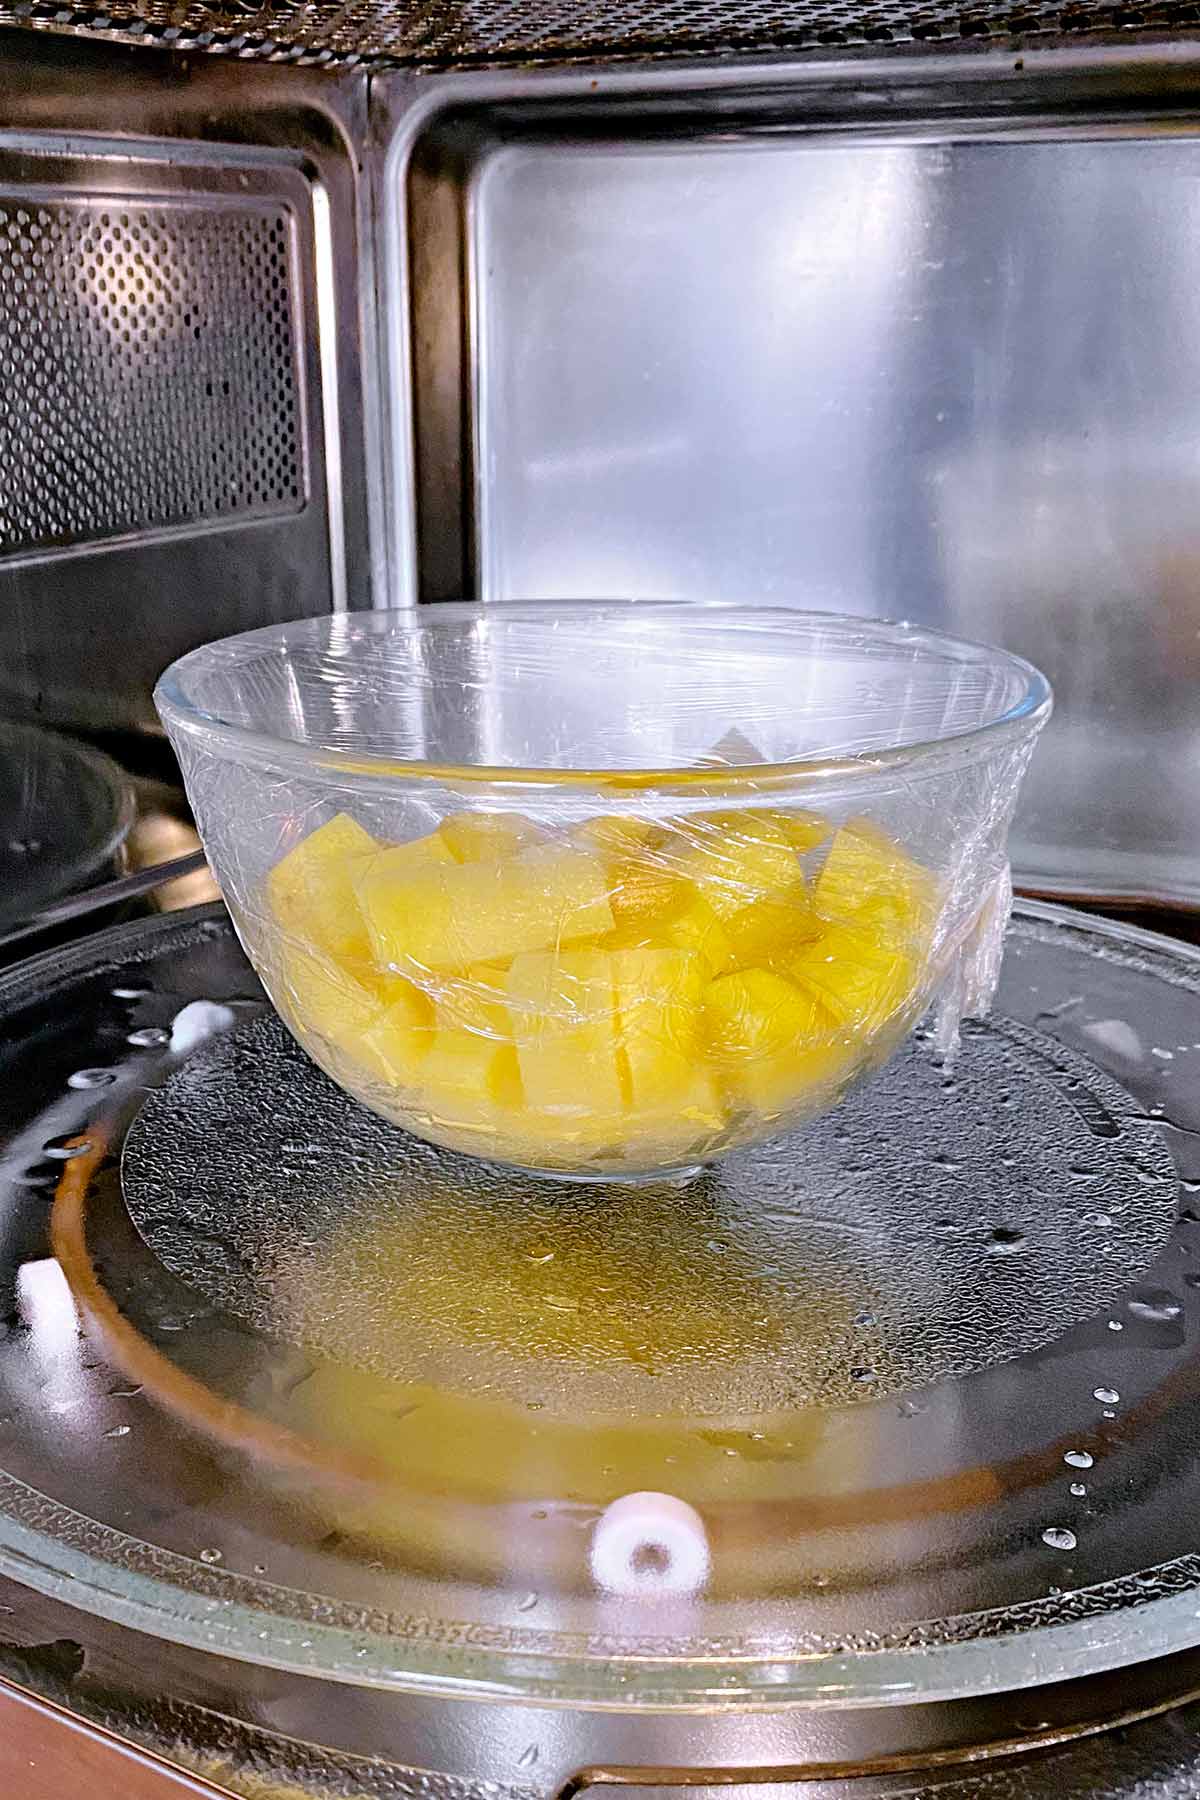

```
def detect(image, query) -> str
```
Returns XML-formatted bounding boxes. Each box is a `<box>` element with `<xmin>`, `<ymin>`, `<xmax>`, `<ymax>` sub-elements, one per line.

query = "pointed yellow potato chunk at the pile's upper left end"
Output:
<box><xmin>266</xmin><ymin>812</ymin><xmax>380</xmax><ymax>963</ymax></box>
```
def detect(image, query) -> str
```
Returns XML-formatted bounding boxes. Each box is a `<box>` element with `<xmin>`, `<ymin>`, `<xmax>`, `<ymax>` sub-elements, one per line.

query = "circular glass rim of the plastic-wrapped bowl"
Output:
<box><xmin>155</xmin><ymin>599</ymin><xmax>1054</xmax><ymax>794</ymax></box>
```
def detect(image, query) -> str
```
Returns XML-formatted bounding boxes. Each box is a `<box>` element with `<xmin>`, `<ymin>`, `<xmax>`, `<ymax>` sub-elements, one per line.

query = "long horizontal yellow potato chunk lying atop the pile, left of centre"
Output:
<box><xmin>358</xmin><ymin>844</ymin><xmax>613</xmax><ymax>970</ymax></box>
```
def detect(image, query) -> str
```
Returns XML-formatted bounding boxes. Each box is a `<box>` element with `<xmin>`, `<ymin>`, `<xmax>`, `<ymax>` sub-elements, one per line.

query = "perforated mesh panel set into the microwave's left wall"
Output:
<box><xmin>0</xmin><ymin>189</ymin><xmax>306</xmax><ymax>556</ymax></box>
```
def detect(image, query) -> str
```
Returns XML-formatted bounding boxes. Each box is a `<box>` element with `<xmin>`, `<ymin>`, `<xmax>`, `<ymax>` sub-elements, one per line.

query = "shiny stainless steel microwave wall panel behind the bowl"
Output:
<box><xmin>378</xmin><ymin>59</ymin><xmax>1200</xmax><ymax>902</ymax></box>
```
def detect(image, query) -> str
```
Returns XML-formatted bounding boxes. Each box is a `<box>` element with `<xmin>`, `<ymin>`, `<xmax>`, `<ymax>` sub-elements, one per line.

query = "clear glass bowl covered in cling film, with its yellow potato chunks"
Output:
<box><xmin>155</xmin><ymin>603</ymin><xmax>1051</xmax><ymax>1179</ymax></box>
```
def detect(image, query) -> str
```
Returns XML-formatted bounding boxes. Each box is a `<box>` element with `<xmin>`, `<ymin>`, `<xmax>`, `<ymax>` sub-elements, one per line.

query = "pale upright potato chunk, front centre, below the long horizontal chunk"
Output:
<box><xmin>507</xmin><ymin>950</ymin><xmax>622</xmax><ymax>1143</ymax></box>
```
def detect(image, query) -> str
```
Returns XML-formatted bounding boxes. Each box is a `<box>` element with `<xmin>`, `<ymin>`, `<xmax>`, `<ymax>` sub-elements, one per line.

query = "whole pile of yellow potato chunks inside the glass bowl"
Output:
<box><xmin>268</xmin><ymin>812</ymin><xmax>937</xmax><ymax>1170</ymax></box>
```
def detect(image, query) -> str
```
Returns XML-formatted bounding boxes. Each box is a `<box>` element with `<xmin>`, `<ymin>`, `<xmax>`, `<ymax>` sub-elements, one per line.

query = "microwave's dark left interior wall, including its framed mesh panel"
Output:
<box><xmin>0</xmin><ymin>32</ymin><xmax>369</xmax><ymax>727</ymax></box>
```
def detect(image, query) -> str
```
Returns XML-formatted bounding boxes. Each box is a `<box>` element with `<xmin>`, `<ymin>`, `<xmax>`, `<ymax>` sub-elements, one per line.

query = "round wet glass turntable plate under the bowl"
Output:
<box><xmin>0</xmin><ymin>904</ymin><xmax>1200</xmax><ymax>1710</ymax></box>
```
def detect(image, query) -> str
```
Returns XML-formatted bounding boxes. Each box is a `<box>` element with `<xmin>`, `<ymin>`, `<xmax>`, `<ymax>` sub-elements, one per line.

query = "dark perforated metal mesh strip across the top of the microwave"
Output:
<box><xmin>0</xmin><ymin>0</ymin><xmax>1200</xmax><ymax>67</ymax></box>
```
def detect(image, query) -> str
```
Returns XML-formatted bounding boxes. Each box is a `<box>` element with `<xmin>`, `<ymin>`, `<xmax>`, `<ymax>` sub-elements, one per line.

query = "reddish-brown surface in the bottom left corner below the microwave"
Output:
<box><xmin>0</xmin><ymin>1681</ymin><xmax>228</xmax><ymax>1800</ymax></box>
